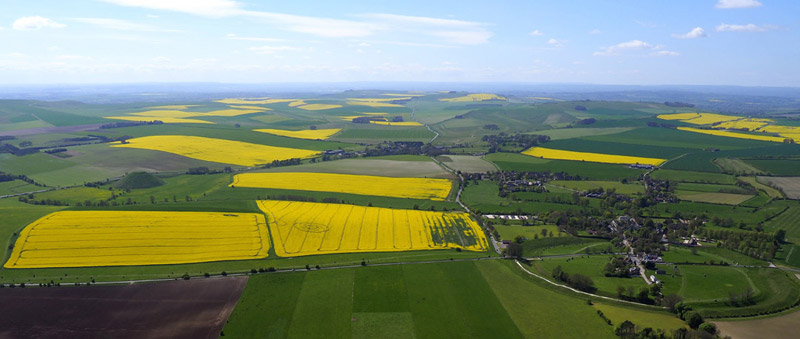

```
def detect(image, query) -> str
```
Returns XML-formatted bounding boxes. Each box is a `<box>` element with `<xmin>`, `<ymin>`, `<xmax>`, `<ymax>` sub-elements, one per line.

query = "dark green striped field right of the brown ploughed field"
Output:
<box><xmin>224</xmin><ymin>262</ymin><xmax>521</xmax><ymax>338</ymax></box>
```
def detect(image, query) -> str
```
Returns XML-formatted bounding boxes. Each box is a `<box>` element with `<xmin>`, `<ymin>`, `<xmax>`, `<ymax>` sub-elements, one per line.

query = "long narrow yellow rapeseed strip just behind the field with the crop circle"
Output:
<box><xmin>231</xmin><ymin>172</ymin><xmax>452</xmax><ymax>201</ymax></box>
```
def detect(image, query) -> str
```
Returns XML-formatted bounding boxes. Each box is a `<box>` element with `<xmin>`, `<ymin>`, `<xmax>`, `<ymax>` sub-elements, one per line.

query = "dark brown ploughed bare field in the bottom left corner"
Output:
<box><xmin>0</xmin><ymin>277</ymin><xmax>247</xmax><ymax>338</ymax></box>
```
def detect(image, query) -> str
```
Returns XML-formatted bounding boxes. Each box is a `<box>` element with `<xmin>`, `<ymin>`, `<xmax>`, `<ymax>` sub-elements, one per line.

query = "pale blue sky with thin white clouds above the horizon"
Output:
<box><xmin>0</xmin><ymin>0</ymin><xmax>800</xmax><ymax>87</ymax></box>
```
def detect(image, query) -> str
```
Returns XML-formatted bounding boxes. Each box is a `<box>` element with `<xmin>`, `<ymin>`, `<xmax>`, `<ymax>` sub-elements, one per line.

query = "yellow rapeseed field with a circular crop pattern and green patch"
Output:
<box><xmin>258</xmin><ymin>200</ymin><xmax>489</xmax><ymax>257</ymax></box>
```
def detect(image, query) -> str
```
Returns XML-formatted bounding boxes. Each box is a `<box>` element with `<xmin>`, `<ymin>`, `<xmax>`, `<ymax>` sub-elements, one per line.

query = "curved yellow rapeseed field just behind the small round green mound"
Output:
<box><xmin>112</xmin><ymin>135</ymin><xmax>320</xmax><ymax>166</ymax></box>
